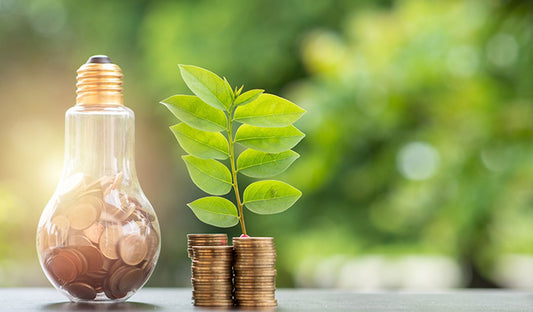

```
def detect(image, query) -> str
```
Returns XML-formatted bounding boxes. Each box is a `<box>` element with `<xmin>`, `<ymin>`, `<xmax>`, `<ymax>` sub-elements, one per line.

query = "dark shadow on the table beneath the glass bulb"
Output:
<box><xmin>43</xmin><ymin>302</ymin><xmax>160</xmax><ymax>311</ymax></box>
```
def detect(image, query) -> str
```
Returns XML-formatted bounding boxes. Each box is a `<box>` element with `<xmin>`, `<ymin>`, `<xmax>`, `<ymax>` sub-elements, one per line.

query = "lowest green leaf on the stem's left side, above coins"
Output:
<box><xmin>187</xmin><ymin>196</ymin><xmax>239</xmax><ymax>227</ymax></box>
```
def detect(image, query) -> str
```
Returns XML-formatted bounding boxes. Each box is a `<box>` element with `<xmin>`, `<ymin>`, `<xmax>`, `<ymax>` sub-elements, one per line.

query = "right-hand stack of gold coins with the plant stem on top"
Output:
<box><xmin>233</xmin><ymin>237</ymin><xmax>278</xmax><ymax>308</ymax></box>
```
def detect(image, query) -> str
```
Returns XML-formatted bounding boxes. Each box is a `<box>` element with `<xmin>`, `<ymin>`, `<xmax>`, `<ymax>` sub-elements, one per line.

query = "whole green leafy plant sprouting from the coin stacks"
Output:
<box><xmin>161</xmin><ymin>65</ymin><xmax>305</xmax><ymax>235</ymax></box>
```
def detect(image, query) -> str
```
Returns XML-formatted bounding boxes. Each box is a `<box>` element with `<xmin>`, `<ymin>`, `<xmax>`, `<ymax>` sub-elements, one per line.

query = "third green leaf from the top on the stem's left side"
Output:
<box><xmin>170</xmin><ymin>122</ymin><xmax>229</xmax><ymax>159</ymax></box>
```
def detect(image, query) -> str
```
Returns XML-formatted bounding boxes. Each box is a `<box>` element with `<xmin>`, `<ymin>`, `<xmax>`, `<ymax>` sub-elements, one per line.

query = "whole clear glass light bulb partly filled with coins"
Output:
<box><xmin>37</xmin><ymin>55</ymin><xmax>160</xmax><ymax>302</ymax></box>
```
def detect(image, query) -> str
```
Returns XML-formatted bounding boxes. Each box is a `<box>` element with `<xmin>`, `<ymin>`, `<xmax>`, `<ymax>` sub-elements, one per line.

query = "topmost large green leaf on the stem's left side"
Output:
<box><xmin>179</xmin><ymin>65</ymin><xmax>232</xmax><ymax>110</ymax></box>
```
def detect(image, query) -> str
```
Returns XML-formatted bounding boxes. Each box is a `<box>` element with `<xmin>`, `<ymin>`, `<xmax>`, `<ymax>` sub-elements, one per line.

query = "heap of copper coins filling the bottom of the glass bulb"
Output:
<box><xmin>38</xmin><ymin>174</ymin><xmax>159</xmax><ymax>301</ymax></box>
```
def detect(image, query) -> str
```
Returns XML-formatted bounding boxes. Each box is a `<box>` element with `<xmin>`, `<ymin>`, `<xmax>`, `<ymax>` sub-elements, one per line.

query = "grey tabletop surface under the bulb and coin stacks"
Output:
<box><xmin>0</xmin><ymin>288</ymin><xmax>533</xmax><ymax>312</ymax></box>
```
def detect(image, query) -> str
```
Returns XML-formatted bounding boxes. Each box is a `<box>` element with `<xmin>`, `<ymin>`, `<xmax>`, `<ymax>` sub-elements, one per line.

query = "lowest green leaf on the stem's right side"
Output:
<box><xmin>243</xmin><ymin>180</ymin><xmax>302</xmax><ymax>214</ymax></box>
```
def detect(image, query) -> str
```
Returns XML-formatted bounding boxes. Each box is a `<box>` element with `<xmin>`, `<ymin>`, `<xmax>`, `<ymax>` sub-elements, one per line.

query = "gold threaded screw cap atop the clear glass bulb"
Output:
<box><xmin>76</xmin><ymin>55</ymin><xmax>124</xmax><ymax>105</ymax></box>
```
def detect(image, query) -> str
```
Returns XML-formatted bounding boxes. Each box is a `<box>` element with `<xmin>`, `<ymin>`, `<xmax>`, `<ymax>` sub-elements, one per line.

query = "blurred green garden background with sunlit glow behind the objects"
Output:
<box><xmin>0</xmin><ymin>0</ymin><xmax>533</xmax><ymax>290</ymax></box>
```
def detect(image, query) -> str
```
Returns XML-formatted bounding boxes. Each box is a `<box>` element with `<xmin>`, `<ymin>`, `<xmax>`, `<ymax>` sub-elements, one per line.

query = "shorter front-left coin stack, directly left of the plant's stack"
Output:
<box><xmin>191</xmin><ymin>246</ymin><xmax>233</xmax><ymax>308</ymax></box>
